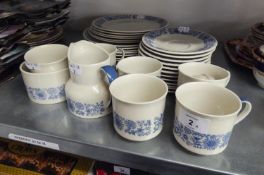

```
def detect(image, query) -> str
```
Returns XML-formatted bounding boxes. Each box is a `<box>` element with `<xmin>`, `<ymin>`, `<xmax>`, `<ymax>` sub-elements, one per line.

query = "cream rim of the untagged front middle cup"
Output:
<box><xmin>109</xmin><ymin>74</ymin><xmax>168</xmax><ymax>105</ymax></box>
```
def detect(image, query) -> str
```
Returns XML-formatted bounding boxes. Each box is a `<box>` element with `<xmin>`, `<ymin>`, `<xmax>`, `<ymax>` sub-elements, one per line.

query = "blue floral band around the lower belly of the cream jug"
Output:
<box><xmin>67</xmin><ymin>98</ymin><xmax>105</xmax><ymax>117</ymax></box>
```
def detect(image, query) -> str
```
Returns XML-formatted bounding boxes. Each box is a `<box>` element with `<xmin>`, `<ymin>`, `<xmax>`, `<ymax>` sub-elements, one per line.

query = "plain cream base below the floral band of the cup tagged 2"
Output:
<box><xmin>173</xmin><ymin>132</ymin><xmax>227</xmax><ymax>156</ymax></box>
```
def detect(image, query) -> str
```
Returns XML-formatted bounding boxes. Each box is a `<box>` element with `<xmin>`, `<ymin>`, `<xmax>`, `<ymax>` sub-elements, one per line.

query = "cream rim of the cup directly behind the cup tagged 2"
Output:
<box><xmin>178</xmin><ymin>62</ymin><xmax>230</xmax><ymax>82</ymax></box>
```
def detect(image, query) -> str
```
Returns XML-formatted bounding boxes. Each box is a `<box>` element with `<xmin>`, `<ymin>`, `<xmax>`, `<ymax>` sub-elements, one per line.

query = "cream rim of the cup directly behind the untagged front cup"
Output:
<box><xmin>116</xmin><ymin>56</ymin><xmax>163</xmax><ymax>74</ymax></box>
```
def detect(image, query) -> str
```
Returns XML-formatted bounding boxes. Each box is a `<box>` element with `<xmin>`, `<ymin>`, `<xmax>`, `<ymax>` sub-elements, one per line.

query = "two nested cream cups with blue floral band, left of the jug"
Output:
<box><xmin>20</xmin><ymin>44</ymin><xmax>69</xmax><ymax>104</ymax></box>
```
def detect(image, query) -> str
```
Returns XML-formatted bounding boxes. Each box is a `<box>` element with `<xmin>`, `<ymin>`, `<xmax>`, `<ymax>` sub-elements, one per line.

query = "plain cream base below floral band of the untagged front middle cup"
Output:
<box><xmin>114</xmin><ymin>126</ymin><xmax>162</xmax><ymax>142</ymax></box>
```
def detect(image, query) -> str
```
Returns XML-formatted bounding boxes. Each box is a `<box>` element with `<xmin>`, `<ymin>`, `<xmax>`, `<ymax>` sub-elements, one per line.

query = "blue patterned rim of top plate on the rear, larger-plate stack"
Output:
<box><xmin>92</xmin><ymin>14</ymin><xmax>168</xmax><ymax>33</ymax></box>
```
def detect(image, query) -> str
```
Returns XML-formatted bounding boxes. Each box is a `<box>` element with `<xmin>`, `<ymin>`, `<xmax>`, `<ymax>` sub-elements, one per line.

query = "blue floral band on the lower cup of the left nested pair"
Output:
<box><xmin>26</xmin><ymin>85</ymin><xmax>65</xmax><ymax>100</ymax></box>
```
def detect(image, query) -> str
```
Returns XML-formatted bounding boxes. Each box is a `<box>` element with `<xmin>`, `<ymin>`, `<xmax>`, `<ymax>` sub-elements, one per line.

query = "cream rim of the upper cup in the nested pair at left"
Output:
<box><xmin>24</xmin><ymin>44</ymin><xmax>68</xmax><ymax>66</ymax></box>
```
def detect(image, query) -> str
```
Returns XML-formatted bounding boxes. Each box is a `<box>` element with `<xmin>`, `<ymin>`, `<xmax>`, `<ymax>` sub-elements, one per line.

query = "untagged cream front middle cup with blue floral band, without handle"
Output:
<box><xmin>109</xmin><ymin>74</ymin><xmax>168</xmax><ymax>141</ymax></box>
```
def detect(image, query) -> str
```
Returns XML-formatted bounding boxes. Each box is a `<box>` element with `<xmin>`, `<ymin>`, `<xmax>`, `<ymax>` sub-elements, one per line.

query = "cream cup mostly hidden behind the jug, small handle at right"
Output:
<box><xmin>96</xmin><ymin>43</ymin><xmax>125</xmax><ymax>66</ymax></box>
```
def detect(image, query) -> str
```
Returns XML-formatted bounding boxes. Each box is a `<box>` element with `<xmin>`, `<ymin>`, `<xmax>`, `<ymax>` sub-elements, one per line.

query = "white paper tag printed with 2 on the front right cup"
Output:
<box><xmin>178</xmin><ymin>108</ymin><xmax>210</xmax><ymax>134</ymax></box>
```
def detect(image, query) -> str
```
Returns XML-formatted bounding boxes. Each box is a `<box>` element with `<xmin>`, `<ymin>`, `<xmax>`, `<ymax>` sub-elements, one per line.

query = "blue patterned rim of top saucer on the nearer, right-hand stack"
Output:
<box><xmin>142</xmin><ymin>27</ymin><xmax>218</xmax><ymax>55</ymax></box>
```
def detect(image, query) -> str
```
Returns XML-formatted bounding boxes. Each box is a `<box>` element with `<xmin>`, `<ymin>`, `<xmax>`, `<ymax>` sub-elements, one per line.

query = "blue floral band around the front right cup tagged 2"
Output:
<box><xmin>173</xmin><ymin>119</ymin><xmax>231</xmax><ymax>150</ymax></box>
